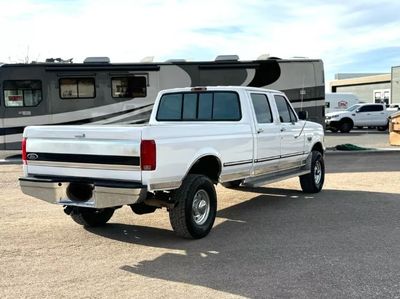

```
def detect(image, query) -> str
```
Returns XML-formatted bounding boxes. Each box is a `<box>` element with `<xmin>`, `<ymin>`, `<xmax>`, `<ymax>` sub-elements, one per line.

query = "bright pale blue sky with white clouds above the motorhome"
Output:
<box><xmin>0</xmin><ymin>0</ymin><xmax>400</xmax><ymax>82</ymax></box>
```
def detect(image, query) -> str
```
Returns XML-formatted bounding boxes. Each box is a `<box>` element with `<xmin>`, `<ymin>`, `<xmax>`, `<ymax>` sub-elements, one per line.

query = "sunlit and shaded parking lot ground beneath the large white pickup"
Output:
<box><xmin>0</xmin><ymin>152</ymin><xmax>400</xmax><ymax>298</ymax></box>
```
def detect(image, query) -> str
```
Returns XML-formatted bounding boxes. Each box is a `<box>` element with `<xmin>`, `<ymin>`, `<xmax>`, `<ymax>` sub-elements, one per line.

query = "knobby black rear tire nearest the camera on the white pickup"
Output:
<box><xmin>169</xmin><ymin>174</ymin><xmax>217</xmax><ymax>239</ymax></box>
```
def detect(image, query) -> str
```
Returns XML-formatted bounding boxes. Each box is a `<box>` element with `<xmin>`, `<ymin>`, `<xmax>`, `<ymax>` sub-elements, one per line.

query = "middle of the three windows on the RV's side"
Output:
<box><xmin>60</xmin><ymin>78</ymin><xmax>96</xmax><ymax>99</ymax></box>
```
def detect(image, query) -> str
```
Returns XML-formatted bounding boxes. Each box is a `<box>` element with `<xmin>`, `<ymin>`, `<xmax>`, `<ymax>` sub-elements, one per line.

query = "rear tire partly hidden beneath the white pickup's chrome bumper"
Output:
<box><xmin>70</xmin><ymin>208</ymin><xmax>114</xmax><ymax>227</ymax></box>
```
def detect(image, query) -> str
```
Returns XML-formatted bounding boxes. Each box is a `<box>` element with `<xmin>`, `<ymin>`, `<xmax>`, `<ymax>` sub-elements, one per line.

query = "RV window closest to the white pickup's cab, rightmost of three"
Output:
<box><xmin>111</xmin><ymin>76</ymin><xmax>147</xmax><ymax>98</ymax></box>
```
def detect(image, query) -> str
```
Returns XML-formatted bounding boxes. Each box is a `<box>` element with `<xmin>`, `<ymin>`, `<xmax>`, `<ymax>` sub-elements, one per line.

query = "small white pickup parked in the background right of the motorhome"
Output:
<box><xmin>325</xmin><ymin>104</ymin><xmax>395</xmax><ymax>133</ymax></box>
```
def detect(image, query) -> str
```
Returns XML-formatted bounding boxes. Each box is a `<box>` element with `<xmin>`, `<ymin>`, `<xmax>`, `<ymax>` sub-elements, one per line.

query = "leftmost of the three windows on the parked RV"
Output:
<box><xmin>3</xmin><ymin>80</ymin><xmax>42</xmax><ymax>107</ymax></box>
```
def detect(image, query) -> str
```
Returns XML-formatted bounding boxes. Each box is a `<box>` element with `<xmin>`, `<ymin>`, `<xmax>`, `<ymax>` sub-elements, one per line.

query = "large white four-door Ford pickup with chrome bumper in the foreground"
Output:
<box><xmin>20</xmin><ymin>87</ymin><xmax>325</xmax><ymax>238</ymax></box>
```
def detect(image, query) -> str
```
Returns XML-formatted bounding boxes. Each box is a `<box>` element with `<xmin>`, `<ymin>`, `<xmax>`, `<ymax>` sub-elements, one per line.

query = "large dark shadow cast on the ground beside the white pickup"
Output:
<box><xmin>88</xmin><ymin>187</ymin><xmax>400</xmax><ymax>298</ymax></box>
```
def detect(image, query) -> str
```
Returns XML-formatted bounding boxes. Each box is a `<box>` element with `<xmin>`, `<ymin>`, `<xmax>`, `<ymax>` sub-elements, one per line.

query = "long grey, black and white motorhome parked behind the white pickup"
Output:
<box><xmin>0</xmin><ymin>55</ymin><xmax>325</xmax><ymax>150</ymax></box>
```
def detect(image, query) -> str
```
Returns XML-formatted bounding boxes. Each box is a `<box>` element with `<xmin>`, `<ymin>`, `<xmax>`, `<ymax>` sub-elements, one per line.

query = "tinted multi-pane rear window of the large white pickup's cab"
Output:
<box><xmin>156</xmin><ymin>91</ymin><xmax>242</xmax><ymax>121</ymax></box>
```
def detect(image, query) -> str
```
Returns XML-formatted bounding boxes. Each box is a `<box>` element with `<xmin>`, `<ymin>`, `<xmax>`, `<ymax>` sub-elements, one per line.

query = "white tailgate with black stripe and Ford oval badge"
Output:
<box><xmin>24</xmin><ymin>126</ymin><xmax>142</xmax><ymax>182</ymax></box>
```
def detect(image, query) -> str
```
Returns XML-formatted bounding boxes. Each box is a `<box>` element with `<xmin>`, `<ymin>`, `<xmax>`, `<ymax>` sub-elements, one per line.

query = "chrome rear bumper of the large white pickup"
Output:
<box><xmin>19</xmin><ymin>177</ymin><xmax>147</xmax><ymax>209</ymax></box>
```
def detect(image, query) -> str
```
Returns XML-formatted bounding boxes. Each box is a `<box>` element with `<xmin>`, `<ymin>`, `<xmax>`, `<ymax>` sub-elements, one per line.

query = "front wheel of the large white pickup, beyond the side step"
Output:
<box><xmin>299</xmin><ymin>151</ymin><xmax>325</xmax><ymax>193</ymax></box>
